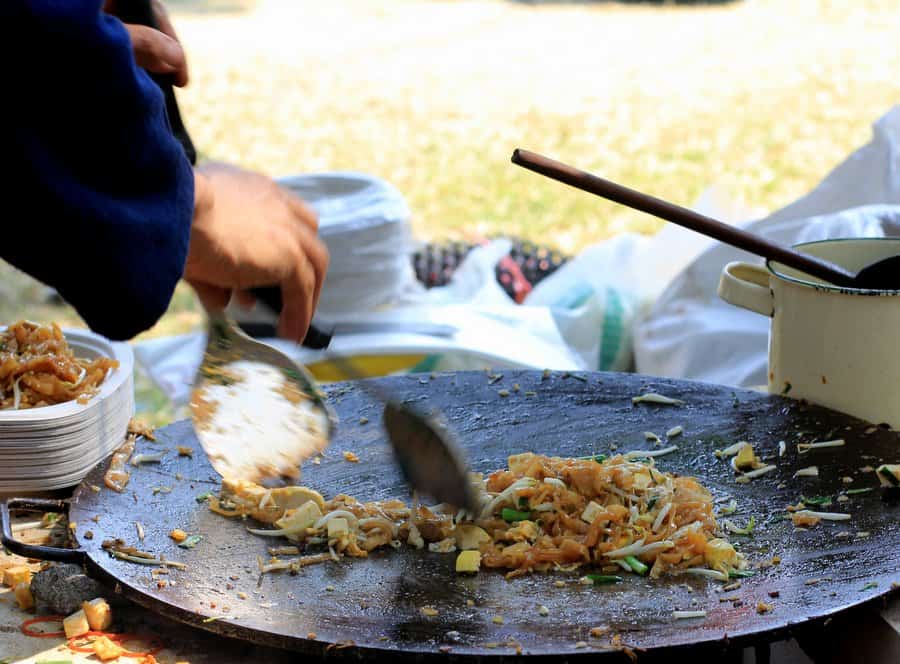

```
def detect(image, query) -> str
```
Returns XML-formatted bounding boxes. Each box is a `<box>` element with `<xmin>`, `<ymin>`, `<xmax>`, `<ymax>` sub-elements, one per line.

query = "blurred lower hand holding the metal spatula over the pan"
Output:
<box><xmin>184</xmin><ymin>164</ymin><xmax>328</xmax><ymax>342</ymax></box>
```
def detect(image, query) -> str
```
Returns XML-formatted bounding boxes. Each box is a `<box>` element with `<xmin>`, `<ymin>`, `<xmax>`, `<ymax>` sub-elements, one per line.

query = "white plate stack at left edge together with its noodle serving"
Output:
<box><xmin>0</xmin><ymin>321</ymin><xmax>134</xmax><ymax>493</ymax></box>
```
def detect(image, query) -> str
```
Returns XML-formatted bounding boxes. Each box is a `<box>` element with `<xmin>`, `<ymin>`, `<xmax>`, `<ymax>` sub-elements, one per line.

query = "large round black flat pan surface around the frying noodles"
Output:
<box><xmin>7</xmin><ymin>372</ymin><xmax>900</xmax><ymax>661</ymax></box>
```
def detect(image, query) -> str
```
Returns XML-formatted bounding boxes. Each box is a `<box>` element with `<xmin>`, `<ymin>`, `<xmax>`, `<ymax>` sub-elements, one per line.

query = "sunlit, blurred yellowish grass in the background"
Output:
<box><xmin>0</xmin><ymin>0</ymin><xmax>900</xmax><ymax>422</ymax></box>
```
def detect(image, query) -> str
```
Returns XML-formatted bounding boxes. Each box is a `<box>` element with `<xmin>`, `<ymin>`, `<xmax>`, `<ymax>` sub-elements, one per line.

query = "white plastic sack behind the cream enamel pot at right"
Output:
<box><xmin>634</xmin><ymin>107</ymin><xmax>900</xmax><ymax>386</ymax></box>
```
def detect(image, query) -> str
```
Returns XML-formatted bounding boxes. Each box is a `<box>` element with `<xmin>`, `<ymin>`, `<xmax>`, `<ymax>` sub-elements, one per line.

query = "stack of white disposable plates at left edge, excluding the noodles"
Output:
<box><xmin>0</xmin><ymin>328</ymin><xmax>134</xmax><ymax>493</ymax></box>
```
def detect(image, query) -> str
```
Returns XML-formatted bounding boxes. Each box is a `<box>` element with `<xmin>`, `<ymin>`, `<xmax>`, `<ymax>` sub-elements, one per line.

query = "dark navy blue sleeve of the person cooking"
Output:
<box><xmin>0</xmin><ymin>0</ymin><xmax>194</xmax><ymax>339</ymax></box>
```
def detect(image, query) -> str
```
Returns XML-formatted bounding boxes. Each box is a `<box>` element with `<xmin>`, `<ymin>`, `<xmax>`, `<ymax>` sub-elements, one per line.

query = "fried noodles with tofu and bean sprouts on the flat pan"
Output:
<box><xmin>209</xmin><ymin>453</ymin><xmax>746</xmax><ymax>581</ymax></box>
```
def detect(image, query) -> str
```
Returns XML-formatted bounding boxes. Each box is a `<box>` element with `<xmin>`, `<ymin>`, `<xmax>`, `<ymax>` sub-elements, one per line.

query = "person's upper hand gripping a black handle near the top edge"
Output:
<box><xmin>103</xmin><ymin>0</ymin><xmax>188</xmax><ymax>87</ymax></box>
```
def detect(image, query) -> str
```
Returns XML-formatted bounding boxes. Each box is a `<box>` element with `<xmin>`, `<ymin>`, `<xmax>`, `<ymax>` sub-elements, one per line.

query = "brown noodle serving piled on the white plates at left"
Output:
<box><xmin>0</xmin><ymin>321</ymin><xmax>119</xmax><ymax>410</ymax></box>
